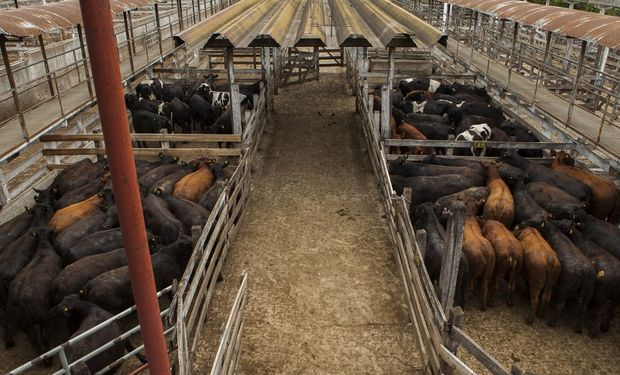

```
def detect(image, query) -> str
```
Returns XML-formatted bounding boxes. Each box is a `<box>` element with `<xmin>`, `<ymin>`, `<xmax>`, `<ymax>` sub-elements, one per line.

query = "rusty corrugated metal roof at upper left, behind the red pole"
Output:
<box><xmin>0</xmin><ymin>0</ymin><xmax>155</xmax><ymax>37</ymax></box>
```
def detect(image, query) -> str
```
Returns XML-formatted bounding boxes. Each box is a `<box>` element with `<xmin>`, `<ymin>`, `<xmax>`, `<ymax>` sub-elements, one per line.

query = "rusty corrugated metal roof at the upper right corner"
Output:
<box><xmin>442</xmin><ymin>0</ymin><xmax>620</xmax><ymax>49</ymax></box>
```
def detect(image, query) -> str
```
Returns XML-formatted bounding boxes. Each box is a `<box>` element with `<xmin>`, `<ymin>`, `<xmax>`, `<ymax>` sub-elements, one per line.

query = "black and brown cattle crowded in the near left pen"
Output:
<box><xmin>0</xmin><ymin>155</ymin><xmax>233</xmax><ymax>373</ymax></box>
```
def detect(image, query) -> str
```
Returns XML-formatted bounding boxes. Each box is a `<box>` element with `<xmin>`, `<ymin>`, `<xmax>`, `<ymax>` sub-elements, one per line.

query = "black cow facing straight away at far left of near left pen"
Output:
<box><xmin>7</xmin><ymin>227</ymin><xmax>63</xmax><ymax>365</ymax></box>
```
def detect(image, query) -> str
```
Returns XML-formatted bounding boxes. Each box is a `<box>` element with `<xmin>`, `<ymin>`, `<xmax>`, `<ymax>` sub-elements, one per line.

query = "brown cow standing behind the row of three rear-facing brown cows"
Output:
<box><xmin>480</xmin><ymin>163</ymin><xmax>515</xmax><ymax>228</ymax></box>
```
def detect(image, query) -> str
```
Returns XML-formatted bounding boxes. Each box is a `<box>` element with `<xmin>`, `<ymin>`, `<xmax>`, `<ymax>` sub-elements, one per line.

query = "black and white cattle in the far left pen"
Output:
<box><xmin>125</xmin><ymin>74</ymin><xmax>263</xmax><ymax>140</ymax></box>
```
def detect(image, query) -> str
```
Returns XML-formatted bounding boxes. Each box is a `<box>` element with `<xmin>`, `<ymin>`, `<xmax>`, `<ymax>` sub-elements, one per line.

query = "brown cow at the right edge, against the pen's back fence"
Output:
<box><xmin>551</xmin><ymin>151</ymin><xmax>620</xmax><ymax>223</ymax></box>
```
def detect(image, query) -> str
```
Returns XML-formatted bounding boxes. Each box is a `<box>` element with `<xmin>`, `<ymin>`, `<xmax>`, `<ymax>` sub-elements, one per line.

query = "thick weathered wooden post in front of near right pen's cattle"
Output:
<box><xmin>439</xmin><ymin>202</ymin><xmax>465</xmax><ymax>313</ymax></box>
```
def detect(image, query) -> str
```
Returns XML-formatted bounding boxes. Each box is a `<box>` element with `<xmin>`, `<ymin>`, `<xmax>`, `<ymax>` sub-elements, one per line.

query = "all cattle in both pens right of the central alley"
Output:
<box><xmin>388</xmin><ymin>79</ymin><xmax>620</xmax><ymax>336</ymax></box>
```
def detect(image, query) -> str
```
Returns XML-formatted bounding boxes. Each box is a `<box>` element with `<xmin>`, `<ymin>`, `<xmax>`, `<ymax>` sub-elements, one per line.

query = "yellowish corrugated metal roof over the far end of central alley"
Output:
<box><xmin>175</xmin><ymin>0</ymin><xmax>447</xmax><ymax>48</ymax></box>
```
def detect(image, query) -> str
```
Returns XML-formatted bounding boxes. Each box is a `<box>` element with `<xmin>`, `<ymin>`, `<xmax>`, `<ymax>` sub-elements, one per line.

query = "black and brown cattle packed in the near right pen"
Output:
<box><xmin>389</xmin><ymin>151</ymin><xmax>620</xmax><ymax>336</ymax></box>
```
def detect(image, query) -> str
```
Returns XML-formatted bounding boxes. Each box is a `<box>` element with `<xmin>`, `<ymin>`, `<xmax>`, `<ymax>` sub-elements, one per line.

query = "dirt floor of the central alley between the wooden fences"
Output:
<box><xmin>196</xmin><ymin>70</ymin><xmax>420</xmax><ymax>374</ymax></box>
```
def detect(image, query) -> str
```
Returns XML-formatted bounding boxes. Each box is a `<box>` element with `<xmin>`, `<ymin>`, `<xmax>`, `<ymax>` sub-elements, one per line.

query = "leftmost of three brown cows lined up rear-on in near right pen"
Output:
<box><xmin>463</xmin><ymin>216</ymin><xmax>495</xmax><ymax>310</ymax></box>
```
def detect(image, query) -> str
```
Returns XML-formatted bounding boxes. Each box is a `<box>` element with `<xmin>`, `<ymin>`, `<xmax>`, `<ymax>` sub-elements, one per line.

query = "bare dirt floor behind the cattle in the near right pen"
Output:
<box><xmin>459</xmin><ymin>285</ymin><xmax>620</xmax><ymax>375</ymax></box>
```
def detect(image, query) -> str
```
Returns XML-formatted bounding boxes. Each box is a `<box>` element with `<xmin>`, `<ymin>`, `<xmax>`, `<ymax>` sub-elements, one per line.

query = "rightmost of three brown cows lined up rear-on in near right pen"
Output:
<box><xmin>515</xmin><ymin>227</ymin><xmax>561</xmax><ymax>324</ymax></box>
